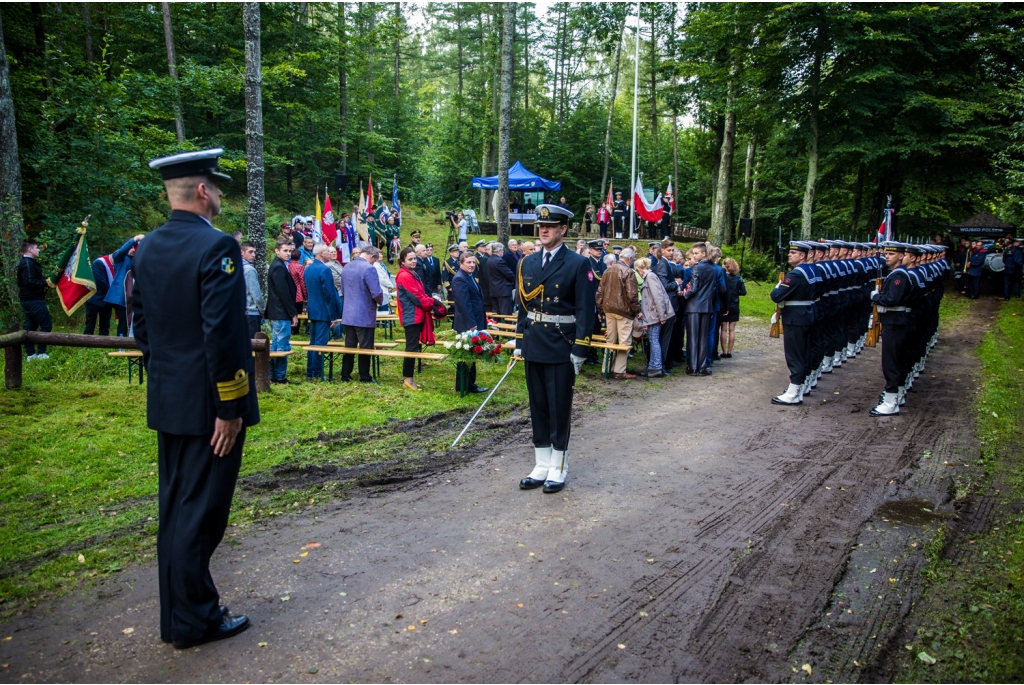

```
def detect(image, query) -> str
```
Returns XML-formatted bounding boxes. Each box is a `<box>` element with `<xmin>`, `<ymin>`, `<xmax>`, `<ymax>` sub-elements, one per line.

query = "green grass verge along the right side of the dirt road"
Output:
<box><xmin>897</xmin><ymin>295</ymin><xmax>1024</xmax><ymax>683</ymax></box>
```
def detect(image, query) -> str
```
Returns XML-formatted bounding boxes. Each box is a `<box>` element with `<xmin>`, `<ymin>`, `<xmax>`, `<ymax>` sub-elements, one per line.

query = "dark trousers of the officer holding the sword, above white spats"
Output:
<box><xmin>525</xmin><ymin>361</ymin><xmax>575</xmax><ymax>451</ymax></box>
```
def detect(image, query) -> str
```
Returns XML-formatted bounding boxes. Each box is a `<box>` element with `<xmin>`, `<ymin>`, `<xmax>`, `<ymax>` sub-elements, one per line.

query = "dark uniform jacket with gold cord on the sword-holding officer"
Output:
<box><xmin>516</xmin><ymin>245</ymin><xmax>595</xmax><ymax>363</ymax></box>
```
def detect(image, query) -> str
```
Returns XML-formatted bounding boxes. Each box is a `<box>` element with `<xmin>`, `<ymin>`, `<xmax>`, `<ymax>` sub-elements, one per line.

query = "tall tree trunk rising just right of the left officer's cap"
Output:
<box><xmin>242</xmin><ymin>2</ymin><xmax>267</xmax><ymax>292</ymax></box>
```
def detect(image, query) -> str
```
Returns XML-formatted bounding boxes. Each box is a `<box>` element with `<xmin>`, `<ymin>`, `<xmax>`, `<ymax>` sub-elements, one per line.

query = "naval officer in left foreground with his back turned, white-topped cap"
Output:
<box><xmin>132</xmin><ymin>148</ymin><xmax>259</xmax><ymax>649</ymax></box>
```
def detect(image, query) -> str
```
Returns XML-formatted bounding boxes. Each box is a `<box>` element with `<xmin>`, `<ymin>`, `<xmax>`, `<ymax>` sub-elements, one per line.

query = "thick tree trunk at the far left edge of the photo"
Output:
<box><xmin>0</xmin><ymin>10</ymin><xmax>25</xmax><ymax>311</ymax></box>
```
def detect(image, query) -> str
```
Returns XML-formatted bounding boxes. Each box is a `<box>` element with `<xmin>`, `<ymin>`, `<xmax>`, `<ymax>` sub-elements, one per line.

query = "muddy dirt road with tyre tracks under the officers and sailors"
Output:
<box><xmin>0</xmin><ymin>307</ymin><xmax>992</xmax><ymax>682</ymax></box>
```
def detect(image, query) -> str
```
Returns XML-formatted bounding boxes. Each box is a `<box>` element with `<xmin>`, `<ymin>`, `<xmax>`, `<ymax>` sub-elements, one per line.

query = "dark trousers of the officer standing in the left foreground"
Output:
<box><xmin>157</xmin><ymin>428</ymin><xmax>246</xmax><ymax>642</ymax></box>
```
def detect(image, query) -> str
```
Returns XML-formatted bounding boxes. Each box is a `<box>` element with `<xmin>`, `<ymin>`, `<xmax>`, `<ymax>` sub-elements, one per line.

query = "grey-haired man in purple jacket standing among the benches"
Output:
<box><xmin>341</xmin><ymin>247</ymin><xmax>384</xmax><ymax>383</ymax></box>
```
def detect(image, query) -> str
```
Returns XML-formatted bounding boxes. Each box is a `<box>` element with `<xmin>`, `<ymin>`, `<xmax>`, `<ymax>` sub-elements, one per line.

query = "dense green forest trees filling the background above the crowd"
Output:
<box><xmin>0</xmin><ymin>2</ymin><xmax>1024</xmax><ymax>325</ymax></box>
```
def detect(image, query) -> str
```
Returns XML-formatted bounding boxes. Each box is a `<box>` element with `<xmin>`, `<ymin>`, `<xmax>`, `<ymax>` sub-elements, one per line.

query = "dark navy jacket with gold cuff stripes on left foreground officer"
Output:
<box><xmin>132</xmin><ymin>210</ymin><xmax>259</xmax><ymax>435</ymax></box>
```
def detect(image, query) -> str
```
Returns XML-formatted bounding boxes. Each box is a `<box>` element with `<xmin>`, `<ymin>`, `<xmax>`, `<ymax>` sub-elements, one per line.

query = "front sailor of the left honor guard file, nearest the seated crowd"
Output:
<box><xmin>770</xmin><ymin>241</ymin><xmax>816</xmax><ymax>404</ymax></box>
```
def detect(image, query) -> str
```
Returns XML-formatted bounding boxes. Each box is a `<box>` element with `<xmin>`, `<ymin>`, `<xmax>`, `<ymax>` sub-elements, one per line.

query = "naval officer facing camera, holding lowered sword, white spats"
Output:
<box><xmin>515</xmin><ymin>205</ymin><xmax>594</xmax><ymax>493</ymax></box>
